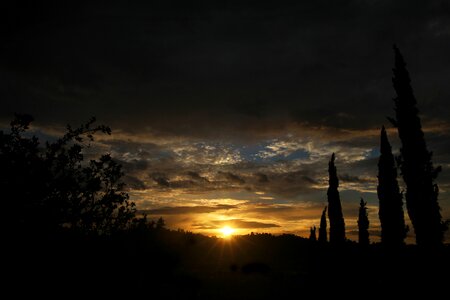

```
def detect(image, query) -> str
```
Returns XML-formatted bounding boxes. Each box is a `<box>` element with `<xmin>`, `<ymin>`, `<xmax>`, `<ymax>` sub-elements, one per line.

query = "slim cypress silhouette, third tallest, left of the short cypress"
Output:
<box><xmin>327</xmin><ymin>153</ymin><xmax>345</xmax><ymax>244</ymax></box>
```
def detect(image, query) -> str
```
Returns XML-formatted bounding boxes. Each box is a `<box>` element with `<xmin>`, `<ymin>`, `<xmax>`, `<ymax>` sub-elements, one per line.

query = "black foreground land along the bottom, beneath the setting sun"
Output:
<box><xmin>3</xmin><ymin>229</ymin><xmax>450</xmax><ymax>299</ymax></box>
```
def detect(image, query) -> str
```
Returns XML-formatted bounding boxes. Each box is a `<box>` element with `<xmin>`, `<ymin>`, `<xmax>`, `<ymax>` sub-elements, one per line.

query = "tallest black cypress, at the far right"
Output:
<box><xmin>391</xmin><ymin>46</ymin><xmax>447</xmax><ymax>246</ymax></box>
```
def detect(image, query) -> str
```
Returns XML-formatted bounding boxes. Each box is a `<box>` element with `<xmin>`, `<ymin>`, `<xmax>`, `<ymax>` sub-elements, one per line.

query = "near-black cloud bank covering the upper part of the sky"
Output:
<box><xmin>0</xmin><ymin>0</ymin><xmax>450</xmax><ymax>135</ymax></box>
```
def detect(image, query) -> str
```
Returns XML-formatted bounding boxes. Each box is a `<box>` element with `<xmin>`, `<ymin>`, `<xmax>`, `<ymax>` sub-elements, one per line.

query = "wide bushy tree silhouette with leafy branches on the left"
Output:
<box><xmin>0</xmin><ymin>115</ymin><xmax>135</xmax><ymax>234</ymax></box>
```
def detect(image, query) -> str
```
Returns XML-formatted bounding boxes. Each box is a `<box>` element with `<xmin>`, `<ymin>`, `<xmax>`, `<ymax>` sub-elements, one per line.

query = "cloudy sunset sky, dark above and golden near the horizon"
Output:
<box><xmin>0</xmin><ymin>0</ymin><xmax>450</xmax><ymax>241</ymax></box>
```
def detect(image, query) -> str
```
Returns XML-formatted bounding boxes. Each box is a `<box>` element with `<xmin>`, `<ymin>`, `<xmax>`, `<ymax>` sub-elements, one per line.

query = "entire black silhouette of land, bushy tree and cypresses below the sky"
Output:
<box><xmin>0</xmin><ymin>48</ymin><xmax>450</xmax><ymax>299</ymax></box>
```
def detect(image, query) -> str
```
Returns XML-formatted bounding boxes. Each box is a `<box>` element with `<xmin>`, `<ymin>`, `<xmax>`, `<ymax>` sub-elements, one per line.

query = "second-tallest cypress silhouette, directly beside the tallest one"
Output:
<box><xmin>377</xmin><ymin>126</ymin><xmax>408</xmax><ymax>246</ymax></box>
